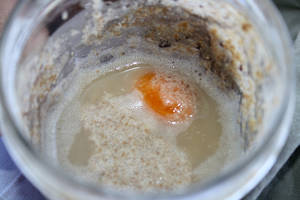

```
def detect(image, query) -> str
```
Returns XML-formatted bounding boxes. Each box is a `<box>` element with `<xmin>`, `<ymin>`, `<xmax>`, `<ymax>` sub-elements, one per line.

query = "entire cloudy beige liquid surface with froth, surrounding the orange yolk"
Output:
<box><xmin>44</xmin><ymin>59</ymin><xmax>242</xmax><ymax>191</ymax></box>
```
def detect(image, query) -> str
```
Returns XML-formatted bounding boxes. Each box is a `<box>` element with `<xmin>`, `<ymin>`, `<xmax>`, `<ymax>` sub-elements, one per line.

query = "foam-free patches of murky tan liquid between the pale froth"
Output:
<box><xmin>69</xmin><ymin>65</ymin><xmax>221</xmax><ymax>168</ymax></box>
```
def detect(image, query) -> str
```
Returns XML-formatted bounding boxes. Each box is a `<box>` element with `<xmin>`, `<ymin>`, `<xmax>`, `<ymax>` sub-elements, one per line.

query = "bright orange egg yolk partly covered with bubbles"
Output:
<box><xmin>135</xmin><ymin>72</ymin><xmax>194</xmax><ymax>122</ymax></box>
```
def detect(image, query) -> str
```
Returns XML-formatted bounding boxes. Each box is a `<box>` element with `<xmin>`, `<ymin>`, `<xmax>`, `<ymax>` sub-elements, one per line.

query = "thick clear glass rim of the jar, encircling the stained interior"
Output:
<box><xmin>0</xmin><ymin>0</ymin><xmax>295</xmax><ymax>200</ymax></box>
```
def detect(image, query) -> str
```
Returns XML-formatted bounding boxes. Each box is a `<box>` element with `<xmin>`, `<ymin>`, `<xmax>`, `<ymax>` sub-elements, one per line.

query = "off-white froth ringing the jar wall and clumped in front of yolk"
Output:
<box><xmin>43</xmin><ymin>53</ymin><xmax>242</xmax><ymax>189</ymax></box>
